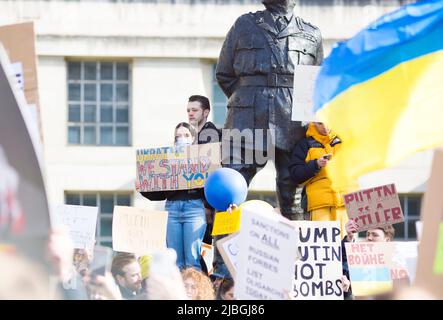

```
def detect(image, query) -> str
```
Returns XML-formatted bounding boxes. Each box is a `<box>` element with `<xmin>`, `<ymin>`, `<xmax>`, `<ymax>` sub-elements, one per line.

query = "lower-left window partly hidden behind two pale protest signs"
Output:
<box><xmin>65</xmin><ymin>192</ymin><xmax>132</xmax><ymax>248</ymax></box>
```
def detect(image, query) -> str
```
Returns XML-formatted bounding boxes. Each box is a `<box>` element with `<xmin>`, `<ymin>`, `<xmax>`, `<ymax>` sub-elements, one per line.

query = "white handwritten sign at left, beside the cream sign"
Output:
<box><xmin>52</xmin><ymin>205</ymin><xmax>98</xmax><ymax>250</ymax></box>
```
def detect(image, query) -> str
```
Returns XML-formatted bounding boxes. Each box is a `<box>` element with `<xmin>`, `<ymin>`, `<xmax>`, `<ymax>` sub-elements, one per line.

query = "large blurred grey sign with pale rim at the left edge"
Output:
<box><xmin>0</xmin><ymin>45</ymin><xmax>50</xmax><ymax>264</ymax></box>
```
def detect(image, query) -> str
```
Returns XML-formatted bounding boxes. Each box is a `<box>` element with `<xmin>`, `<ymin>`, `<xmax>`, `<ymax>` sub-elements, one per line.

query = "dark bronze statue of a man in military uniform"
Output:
<box><xmin>216</xmin><ymin>0</ymin><xmax>323</xmax><ymax>220</ymax></box>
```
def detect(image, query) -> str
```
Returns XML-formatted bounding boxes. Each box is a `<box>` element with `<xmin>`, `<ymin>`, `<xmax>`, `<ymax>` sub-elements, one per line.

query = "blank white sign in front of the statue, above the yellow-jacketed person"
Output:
<box><xmin>291</xmin><ymin>65</ymin><xmax>321</xmax><ymax>122</ymax></box>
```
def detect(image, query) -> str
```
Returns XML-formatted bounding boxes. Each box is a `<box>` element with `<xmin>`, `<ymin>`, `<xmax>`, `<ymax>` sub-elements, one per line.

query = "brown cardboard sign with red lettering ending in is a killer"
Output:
<box><xmin>344</xmin><ymin>184</ymin><xmax>404</xmax><ymax>232</ymax></box>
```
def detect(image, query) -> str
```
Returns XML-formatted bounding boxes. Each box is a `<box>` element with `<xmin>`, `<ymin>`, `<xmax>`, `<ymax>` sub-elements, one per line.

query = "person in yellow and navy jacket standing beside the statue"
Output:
<box><xmin>289</xmin><ymin>122</ymin><xmax>354</xmax><ymax>238</ymax></box>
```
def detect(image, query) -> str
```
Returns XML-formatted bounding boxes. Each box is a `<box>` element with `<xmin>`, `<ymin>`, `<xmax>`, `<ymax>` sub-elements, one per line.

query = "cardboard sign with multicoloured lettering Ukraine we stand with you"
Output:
<box><xmin>137</xmin><ymin>143</ymin><xmax>221</xmax><ymax>192</ymax></box>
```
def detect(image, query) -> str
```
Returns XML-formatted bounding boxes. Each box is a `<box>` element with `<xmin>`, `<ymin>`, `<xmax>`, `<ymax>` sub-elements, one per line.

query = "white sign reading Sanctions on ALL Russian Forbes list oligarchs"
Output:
<box><xmin>235</xmin><ymin>208</ymin><xmax>297</xmax><ymax>300</ymax></box>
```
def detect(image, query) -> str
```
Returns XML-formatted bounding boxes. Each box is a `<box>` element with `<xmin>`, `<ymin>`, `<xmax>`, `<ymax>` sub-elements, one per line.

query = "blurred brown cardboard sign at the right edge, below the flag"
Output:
<box><xmin>415</xmin><ymin>149</ymin><xmax>443</xmax><ymax>299</ymax></box>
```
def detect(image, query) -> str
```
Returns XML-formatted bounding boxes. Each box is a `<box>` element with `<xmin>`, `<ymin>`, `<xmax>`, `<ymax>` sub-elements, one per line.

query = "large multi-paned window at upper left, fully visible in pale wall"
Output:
<box><xmin>67</xmin><ymin>61</ymin><xmax>131</xmax><ymax>146</ymax></box>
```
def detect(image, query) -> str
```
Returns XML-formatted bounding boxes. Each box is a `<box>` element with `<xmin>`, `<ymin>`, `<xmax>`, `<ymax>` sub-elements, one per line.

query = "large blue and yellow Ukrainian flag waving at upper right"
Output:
<box><xmin>314</xmin><ymin>0</ymin><xmax>443</xmax><ymax>189</ymax></box>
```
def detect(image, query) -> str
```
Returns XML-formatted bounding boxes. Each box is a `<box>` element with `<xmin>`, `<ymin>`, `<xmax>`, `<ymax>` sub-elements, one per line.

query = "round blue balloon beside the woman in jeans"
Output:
<box><xmin>205</xmin><ymin>168</ymin><xmax>248</xmax><ymax>211</ymax></box>
